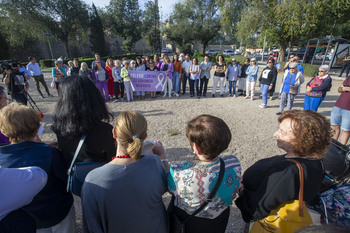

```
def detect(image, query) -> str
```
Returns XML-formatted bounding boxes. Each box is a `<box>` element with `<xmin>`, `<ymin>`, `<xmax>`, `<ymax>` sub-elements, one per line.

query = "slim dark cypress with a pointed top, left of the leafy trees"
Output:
<box><xmin>89</xmin><ymin>3</ymin><xmax>106</xmax><ymax>56</ymax></box>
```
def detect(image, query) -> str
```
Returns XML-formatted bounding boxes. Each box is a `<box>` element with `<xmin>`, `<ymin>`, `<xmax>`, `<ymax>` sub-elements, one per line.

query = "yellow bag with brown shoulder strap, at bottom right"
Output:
<box><xmin>249</xmin><ymin>159</ymin><xmax>312</xmax><ymax>233</ymax></box>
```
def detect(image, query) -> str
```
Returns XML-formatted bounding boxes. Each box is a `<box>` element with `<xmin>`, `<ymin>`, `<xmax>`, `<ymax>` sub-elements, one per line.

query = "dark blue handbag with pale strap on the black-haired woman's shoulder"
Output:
<box><xmin>67</xmin><ymin>134</ymin><xmax>106</xmax><ymax>197</ymax></box>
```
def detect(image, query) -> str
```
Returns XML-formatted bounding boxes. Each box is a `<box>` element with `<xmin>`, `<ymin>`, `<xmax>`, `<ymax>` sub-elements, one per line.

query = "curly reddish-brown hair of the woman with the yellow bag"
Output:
<box><xmin>278</xmin><ymin>110</ymin><xmax>332</xmax><ymax>159</ymax></box>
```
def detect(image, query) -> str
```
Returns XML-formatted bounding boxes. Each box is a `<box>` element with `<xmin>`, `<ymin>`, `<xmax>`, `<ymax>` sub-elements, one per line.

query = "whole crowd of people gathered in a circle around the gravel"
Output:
<box><xmin>0</xmin><ymin>54</ymin><xmax>350</xmax><ymax>233</ymax></box>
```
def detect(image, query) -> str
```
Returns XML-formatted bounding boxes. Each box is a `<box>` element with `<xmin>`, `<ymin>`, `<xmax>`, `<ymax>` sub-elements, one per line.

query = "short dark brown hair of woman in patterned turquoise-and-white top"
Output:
<box><xmin>186</xmin><ymin>115</ymin><xmax>231</xmax><ymax>160</ymax></box>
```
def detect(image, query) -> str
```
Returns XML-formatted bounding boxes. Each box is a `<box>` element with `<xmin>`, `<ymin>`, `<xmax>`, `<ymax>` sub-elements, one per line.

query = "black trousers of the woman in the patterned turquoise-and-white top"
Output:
<box><xmin>174</xmin><ymin>206</ymin><xmax>230</xmax><ymax>233</ymax></box>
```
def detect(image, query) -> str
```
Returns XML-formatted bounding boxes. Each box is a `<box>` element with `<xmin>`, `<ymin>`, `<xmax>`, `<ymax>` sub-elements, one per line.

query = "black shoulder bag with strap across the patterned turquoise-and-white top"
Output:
<box><xmin>167</xmin><ymin>157</ymin><xmax>225</xmax><ymax>233</ymax></box>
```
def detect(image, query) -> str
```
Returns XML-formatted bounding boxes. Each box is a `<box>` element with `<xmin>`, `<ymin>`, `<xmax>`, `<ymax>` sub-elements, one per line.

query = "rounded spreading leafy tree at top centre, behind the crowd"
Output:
<box><xmin>165</xmin><ymin>0</ymin><xmax>220</xmax><ymax>55</ymax></box>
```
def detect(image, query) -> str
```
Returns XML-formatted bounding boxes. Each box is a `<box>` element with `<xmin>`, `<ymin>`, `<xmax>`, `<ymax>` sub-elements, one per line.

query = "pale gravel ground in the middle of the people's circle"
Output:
<box><xmin>15</xmin><ymin>67</ymin><xmax>342</xmax><ymax>232</ymax></box>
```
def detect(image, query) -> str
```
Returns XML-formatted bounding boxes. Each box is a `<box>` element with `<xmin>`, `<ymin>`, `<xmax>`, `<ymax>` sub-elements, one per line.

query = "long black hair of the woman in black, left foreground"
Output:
<box><xmin>51</xmin><ymin>76</ymin><xmax>113</xmax><ymax>137</ymax></box>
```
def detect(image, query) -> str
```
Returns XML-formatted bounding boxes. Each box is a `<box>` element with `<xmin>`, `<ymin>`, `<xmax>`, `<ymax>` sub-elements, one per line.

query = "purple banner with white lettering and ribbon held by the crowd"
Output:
<box><xmin>129</xmin><ymin>70</ymin><xmax>167</xmax><ymax>91</ymax></box>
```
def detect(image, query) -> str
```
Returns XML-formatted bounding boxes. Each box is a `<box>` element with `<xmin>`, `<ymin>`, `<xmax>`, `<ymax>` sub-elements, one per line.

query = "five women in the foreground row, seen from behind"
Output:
<box><xmin>0</xmin><ymin>69</ymin><xmax>344</xmax><ymax>233</ymax></box>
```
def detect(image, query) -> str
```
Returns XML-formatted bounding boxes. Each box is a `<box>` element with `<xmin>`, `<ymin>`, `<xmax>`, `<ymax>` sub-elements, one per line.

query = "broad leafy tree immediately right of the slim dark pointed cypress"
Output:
<box><xmin>108</xmin><ymin>0</ymin><xmax>142</xmax><ymax>52</ymax></box>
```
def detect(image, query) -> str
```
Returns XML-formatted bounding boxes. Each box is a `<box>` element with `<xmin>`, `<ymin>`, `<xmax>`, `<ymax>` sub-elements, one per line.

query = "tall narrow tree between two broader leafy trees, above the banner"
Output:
<box><xmin>142</xmin><ymin>1</ymin><xmax>161</xmax><ymax>53</ymax></box>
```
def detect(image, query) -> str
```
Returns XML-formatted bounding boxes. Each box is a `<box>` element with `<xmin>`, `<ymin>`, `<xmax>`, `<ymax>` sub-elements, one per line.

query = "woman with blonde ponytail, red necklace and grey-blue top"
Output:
<box><xmin>81</xmin><ymin>111</ymin><xmax>168</xmax><ymax>233</ymax></box>
